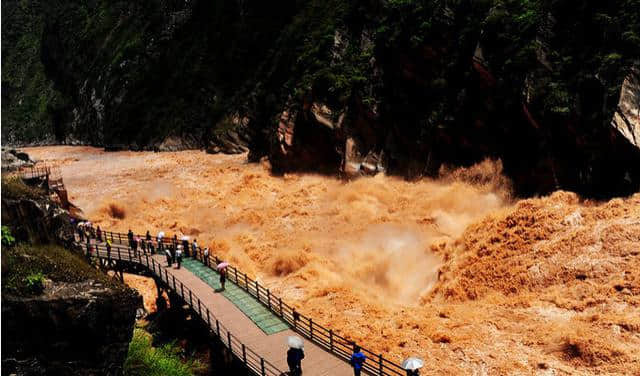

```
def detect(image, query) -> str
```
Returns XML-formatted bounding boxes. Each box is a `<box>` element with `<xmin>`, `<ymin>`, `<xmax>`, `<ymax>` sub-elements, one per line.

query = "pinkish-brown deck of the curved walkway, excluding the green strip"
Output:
<box><xmin>87</xmin><ymin>242</ymin><xmax>353</xmax><ymax>376</ymax></box>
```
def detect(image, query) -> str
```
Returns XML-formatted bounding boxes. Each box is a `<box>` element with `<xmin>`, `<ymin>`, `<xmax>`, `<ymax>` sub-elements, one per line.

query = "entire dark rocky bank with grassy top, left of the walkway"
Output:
<box><xmin>2</xmin><ymin>177</ymin><xmax>142</xmax><ymax>375</ymax></box>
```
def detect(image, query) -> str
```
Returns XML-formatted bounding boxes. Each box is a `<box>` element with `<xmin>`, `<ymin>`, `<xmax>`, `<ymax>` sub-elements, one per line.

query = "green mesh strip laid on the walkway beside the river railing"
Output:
<box><xmin>182</xmin><ymin>258</ymin><xmax>289</xmax><ymax>334</ymax></box>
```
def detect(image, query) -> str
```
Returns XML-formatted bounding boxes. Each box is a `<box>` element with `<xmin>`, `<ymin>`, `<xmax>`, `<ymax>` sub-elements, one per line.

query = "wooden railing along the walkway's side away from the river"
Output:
<box><xmin>84</xmin><ymin>242</ymin><xmax>283</xmax><ymax>376</ymax></box>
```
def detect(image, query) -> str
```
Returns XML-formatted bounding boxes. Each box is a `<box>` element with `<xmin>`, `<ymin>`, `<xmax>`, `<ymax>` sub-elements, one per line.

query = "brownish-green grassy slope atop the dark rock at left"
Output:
<box><xmin>2</xmin><ymin>244</ymin><xmax>121</xmax><ymax>296</ymax></box>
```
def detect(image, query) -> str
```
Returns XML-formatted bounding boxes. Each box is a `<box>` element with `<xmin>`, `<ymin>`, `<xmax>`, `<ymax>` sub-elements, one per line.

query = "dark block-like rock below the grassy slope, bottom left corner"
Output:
<box><xmin>2</xmin><ymin>281</ymin><xmax>141</xmax><ymax>376</ymax></box>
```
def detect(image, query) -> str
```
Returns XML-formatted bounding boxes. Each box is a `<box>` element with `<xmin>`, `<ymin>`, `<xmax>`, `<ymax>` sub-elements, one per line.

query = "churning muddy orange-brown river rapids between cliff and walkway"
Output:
<box><xmin>27</xmin><ymin>147</ymin><xmax>640</xmax><ymax>375</ymax></box>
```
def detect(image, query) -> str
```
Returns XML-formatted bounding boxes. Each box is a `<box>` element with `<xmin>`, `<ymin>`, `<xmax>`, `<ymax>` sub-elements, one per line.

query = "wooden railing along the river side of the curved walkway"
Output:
<box><xmin>80</xmin><ymin>227</ymin><xmax>406</xmax><ymax>376</ymax></box>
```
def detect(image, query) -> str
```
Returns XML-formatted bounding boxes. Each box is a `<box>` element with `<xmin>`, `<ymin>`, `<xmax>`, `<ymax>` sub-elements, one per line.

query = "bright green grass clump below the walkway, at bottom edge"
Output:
<box><xmin>124</xmin><ymin>328</ymin><xmax>205</xmax><ymax>376</ymax></box>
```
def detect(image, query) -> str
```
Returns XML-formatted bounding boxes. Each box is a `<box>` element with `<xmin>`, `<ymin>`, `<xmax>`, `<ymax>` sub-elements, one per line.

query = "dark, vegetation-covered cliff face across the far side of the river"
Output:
<box><xmin>3</xmin><ymin>0</ymin><xmax>640</xmax><ymax>196</ymax></box>
